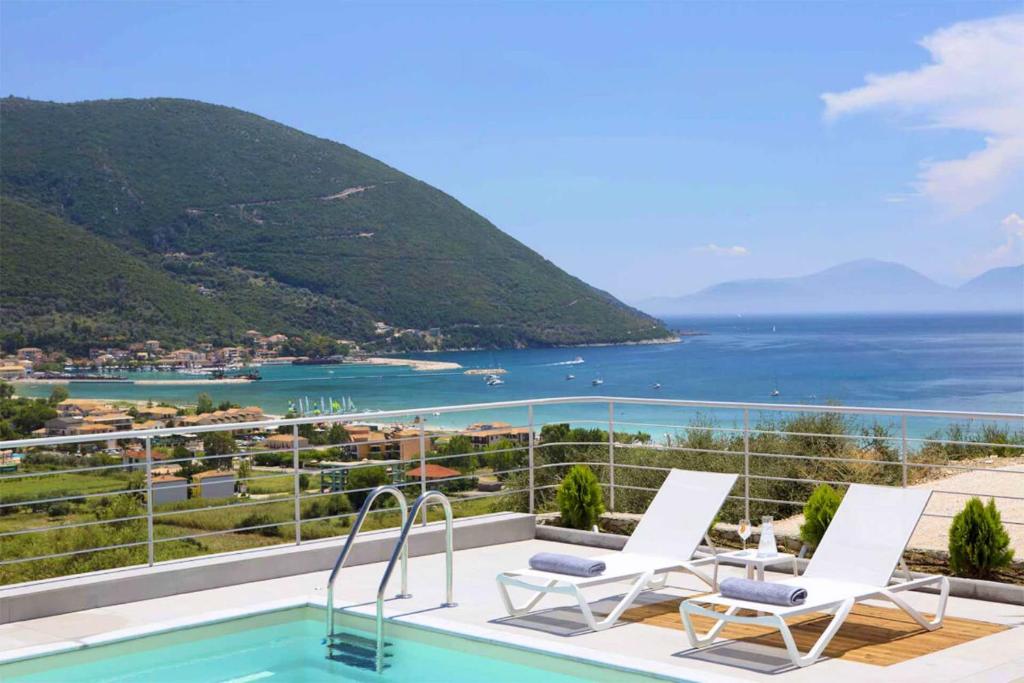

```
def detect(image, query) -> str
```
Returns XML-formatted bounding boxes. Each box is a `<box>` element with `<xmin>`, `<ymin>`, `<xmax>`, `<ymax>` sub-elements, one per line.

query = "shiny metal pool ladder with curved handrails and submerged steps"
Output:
<box><xmin>324</xmin><ymin>485</ymin><xmax>456</xmax><ymax>673</ymax></box>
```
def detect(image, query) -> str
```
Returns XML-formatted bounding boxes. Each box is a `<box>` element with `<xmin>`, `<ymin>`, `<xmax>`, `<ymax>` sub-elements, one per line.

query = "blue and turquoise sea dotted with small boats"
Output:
<box><xmin>12</xmin><ymin>313</ymin><xmax>1024</xmax><ymax>435</ymax></box>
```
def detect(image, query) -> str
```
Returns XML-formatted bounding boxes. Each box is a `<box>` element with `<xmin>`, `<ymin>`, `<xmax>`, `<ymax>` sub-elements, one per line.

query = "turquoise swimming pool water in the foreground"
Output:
<box><xmin>0</xmin><ymin>607</ymin><xmax>671</xmax><ymax>683</ymax></box>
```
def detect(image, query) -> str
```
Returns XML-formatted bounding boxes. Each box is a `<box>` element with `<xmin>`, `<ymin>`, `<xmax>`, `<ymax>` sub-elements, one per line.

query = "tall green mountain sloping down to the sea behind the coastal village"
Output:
<box><xmin>0</xmin><ymin>98</ymin><xmax>668</xmax><ymax>347</ymax></box>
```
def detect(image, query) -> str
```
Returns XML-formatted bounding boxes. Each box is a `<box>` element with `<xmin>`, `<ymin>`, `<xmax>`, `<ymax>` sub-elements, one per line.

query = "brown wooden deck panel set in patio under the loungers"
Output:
<box><xmin>622</xmin><ymin>599</ymin><xmax>1007</xmax><ymax>667</ymax></box>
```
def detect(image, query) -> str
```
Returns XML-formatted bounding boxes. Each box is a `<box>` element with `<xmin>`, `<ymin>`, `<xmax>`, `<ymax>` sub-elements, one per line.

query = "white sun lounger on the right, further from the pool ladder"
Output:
<box><xmin>679</xmin><ymin>484</ymin><xmax>949</xmax><ymax>667</ymax></box>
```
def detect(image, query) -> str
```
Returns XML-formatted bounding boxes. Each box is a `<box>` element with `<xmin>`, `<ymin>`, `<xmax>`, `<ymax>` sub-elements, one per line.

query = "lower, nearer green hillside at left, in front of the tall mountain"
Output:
<box><xmin>0</xmin><ymin>198</ymin><xmax>247</xmax><ymax>348</ymax></box>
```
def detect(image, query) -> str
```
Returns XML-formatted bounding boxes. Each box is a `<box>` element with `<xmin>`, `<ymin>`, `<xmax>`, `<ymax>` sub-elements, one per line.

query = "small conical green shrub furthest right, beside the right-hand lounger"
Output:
<box><xmin>949</xmin><ymin>498</ymin><xmax>1014</xmax><ymax>579</ymax></box>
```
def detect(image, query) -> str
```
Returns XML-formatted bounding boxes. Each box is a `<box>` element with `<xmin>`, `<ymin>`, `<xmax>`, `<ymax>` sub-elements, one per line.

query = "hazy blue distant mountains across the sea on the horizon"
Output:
<box><xmin>637</xmin><ymin>259</ymin><xmax>1024</xmax><ymax>315</ymax></box>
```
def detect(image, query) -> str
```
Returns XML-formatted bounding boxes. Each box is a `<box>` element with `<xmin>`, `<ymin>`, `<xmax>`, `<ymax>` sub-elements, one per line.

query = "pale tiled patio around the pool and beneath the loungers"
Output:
<box><xmin>0</xmin><ymin>540</ymin><xmax>1024</xmax><ymax>683</ymax></box>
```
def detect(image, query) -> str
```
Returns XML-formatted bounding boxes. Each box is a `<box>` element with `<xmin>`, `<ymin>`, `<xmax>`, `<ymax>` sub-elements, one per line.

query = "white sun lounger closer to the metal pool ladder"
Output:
<box><xmin>498</xmin><ymin>470</ymin><xmax>737</xmax><ymax>631</ymax></box>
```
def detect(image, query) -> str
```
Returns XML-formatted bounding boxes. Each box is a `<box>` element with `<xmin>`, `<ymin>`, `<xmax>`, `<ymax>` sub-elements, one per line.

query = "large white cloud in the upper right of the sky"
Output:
<box><xmin>821</xmin><ymin>13</ymin><xmax>1024</xmax><ymax>211</ymax></box>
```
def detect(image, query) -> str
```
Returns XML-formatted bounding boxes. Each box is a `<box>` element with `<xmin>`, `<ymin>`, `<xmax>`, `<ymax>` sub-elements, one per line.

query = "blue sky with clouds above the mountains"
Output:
<box><xmin>0</xmin><ymin>0</ymin><xmax>1024</xmax><ymax>301</ymax></box>
